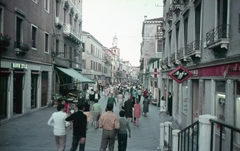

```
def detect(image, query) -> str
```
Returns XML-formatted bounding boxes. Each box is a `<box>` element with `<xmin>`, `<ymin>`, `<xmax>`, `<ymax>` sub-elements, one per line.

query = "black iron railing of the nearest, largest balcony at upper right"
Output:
<box><xmin>206</xmin><ymin>24</ymin><xmax>229</xmax><ymax>46</ymax></box>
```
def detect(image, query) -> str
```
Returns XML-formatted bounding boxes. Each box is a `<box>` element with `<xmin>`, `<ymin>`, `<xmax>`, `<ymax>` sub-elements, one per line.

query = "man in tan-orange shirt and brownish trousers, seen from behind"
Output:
<box><xmin>99</xmin><ymin>103</ymin><xmax>120</xmax><ymax>151</ymax></box>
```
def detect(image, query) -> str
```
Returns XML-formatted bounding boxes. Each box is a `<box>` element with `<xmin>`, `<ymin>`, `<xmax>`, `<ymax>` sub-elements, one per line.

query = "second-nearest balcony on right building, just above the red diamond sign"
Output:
<box><xmin>186</xmin><ymin>40</ymin><xmax>201</xmax><ymax>58</ymax></box>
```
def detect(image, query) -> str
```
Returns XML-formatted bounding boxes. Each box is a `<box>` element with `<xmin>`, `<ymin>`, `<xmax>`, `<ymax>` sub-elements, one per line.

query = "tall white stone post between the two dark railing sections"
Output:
<box><xmin>198</xmin><ymin>114</ymin><xmax>217</xmax><ymax>151</ymax></box>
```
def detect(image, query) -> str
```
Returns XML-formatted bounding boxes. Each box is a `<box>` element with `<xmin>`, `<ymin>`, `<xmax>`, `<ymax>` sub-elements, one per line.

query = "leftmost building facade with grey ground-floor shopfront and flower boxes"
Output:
<box><xmin>0</xmin><ymin>0</ymin><xmax>53</xmax><ymax>121</ymax></box>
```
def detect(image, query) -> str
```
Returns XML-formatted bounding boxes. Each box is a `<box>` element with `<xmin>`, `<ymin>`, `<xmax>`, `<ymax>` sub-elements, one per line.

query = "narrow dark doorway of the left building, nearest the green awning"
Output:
<box><xmin>41</xmin><ymin>71</ymin><xmax>48</xmax><ymax>106</ymax></box>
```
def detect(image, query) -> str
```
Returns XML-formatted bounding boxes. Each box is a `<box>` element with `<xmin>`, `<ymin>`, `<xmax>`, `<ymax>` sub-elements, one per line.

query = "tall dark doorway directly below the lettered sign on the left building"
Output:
<box><xmin>13</xmin><ymin>73</ymin><xmax>23</xmax><ymax>114</ymax></box>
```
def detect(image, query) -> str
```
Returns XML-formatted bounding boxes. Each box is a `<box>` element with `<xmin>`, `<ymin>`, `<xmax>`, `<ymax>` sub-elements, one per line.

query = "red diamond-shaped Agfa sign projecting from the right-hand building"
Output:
<box><xmin>168</xmin><ymin>66</ymin><xmax>192</xmax><ymax>83</ymax></box>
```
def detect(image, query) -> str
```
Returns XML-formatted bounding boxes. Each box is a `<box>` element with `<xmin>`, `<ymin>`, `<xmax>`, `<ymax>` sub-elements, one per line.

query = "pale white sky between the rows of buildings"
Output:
<box><xmin>82</xmin><ymin>0</ymin><xmax>163</xmax><ymax>66</ymax></box>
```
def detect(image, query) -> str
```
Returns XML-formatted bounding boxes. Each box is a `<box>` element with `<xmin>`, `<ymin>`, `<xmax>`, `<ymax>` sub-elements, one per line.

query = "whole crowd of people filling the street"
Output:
<box><xmin>48</xmin><ymin>84</ymin><xmax>171</xmax><ymax>151</ymax></box>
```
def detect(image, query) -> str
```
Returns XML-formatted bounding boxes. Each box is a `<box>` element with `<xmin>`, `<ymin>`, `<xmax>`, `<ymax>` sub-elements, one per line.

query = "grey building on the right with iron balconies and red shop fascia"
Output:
<box><xmin>159</xmin><ymin>0</ymin><xmax>240</xmax><ymax>150</ymax></box>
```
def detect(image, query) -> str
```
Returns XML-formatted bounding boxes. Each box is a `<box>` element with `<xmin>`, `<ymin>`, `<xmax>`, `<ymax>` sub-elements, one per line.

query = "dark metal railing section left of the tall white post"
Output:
<box><xmin>178</xmin><ymin>121</ymin><xmax>199</xmax><ymax>151</ymax></box>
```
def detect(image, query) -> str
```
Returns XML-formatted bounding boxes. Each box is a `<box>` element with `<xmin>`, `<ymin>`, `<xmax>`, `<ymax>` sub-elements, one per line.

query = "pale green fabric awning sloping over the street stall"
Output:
<box><xmin>57</xmin><ymin>67</ymin><xmax>95</xmax><ymax>83</ymax></box>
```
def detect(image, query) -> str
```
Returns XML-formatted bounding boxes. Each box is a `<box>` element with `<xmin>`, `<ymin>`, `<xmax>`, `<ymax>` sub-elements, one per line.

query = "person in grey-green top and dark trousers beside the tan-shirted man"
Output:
<box><xmin>116</xmin><ymin>110</ymin><xmax>131</xmax><ymax>151</ymax></box>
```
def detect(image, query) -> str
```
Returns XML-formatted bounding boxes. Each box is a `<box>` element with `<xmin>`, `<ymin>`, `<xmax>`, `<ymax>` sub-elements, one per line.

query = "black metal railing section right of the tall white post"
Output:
<box><xmin>209</xmin><ymin>119</ymin><xmax>240</xmax><ymax>151</ymax></box>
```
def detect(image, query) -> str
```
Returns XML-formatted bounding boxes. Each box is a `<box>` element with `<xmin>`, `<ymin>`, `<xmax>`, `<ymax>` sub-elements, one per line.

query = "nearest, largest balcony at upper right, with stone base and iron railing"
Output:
<box><xmin>206</xmin><ymin>24</ymin><xmax>230</xmax><ymax>49</ymax></box>
